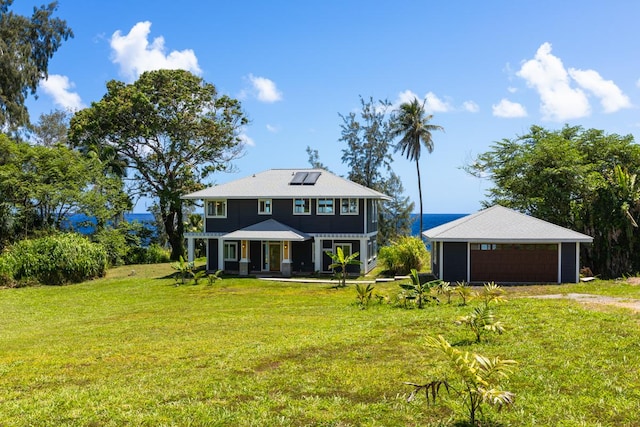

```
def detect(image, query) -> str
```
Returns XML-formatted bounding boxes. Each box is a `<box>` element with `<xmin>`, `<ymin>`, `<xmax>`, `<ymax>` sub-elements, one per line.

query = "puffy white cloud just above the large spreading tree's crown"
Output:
<box><xmin>111</xmin><ymin>21</ymin><xmax>201</xmax><ymax>81</ymax></box>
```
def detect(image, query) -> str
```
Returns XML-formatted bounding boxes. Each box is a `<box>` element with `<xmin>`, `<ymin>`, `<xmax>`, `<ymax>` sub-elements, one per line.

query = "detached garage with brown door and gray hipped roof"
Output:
<box><xmin>423</xmin><ymin>205</ymin><xmax>593</xmax><ymax>283</ymax></box>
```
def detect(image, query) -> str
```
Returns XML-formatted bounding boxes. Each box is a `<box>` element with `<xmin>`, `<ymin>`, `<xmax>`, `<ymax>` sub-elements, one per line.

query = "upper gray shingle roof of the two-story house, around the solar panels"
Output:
<box><xmin>182</xmin><ymin>168</ymin><xmax>391</xmax><ymax>200</ymax></box>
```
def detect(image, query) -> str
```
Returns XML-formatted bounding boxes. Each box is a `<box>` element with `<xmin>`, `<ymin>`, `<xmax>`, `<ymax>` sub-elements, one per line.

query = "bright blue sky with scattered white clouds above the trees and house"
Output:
<box><xmin>14</xmin><ymin>0</ymin><xmax>640</xmax><ymax>213</ymax></box>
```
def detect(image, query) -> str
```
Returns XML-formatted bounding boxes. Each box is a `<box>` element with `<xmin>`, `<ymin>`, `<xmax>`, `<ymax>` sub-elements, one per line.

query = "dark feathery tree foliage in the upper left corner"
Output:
<box><xmin>0</xmin><ymin>0</ymin><xmax>73</xmax><ymax>129</ymax></box>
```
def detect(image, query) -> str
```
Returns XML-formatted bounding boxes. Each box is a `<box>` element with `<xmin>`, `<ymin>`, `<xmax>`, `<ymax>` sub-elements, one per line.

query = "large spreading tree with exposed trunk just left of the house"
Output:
<box><xmin>69</xmin><ymin>70</ymin><xmax>248</xmax><ymax>260</ymax></box>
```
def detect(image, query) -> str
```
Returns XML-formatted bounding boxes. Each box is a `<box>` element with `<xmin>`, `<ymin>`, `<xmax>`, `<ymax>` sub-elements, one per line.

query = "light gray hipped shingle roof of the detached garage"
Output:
<box><xmin>422</xmin><ymin>205</ymin><xmax>593</xmax><ymax>243</ymax></box>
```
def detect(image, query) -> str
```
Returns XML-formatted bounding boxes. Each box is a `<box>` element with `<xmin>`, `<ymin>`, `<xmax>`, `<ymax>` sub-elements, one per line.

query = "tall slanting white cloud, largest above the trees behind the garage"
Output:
<box><xmin>516</xmin><ymin>43</ymin><xmax>591</xmax><ymax>121</ymax></box>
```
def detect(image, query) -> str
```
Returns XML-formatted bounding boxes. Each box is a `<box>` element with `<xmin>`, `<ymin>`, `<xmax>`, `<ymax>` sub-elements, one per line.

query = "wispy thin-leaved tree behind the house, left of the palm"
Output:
<box><xmin>340</xmin><ymin>97</ymin><xmax>413</xmax><ymax>246</ymax></box>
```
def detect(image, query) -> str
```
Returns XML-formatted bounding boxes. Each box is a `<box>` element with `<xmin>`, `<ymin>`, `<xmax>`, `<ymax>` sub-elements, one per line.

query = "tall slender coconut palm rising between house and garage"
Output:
<box><xmin>391</xmin><ymin>98</ymin><xmax>444</xmax><ymax>234</ymax></box>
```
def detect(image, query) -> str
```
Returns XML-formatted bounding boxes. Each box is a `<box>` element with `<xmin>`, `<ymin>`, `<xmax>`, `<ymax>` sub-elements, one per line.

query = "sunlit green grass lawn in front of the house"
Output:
<box><xmin>0</xmin><ymin>264</ymin><xmax>640</xmax><ymax>426</ymax></box>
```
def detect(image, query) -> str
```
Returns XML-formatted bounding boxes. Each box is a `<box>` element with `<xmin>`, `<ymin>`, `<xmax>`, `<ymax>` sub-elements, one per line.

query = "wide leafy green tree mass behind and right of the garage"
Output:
<box><xmin>465</xmin><ymin>126</ymin><xmax>640</xmax><ymax>277</ymax></box>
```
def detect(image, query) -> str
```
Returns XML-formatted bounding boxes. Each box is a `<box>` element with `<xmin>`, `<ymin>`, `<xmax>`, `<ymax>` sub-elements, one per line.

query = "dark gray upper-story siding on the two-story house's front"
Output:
<box><xmin>206</xmin><ymin>199</ymin><xmax>364</xmax><ymax>233</ymax></box>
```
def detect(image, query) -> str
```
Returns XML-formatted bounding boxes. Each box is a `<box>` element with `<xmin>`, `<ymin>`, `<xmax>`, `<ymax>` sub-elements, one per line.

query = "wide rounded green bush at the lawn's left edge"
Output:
<box><xmin>0</xmin><ymin>233</ymin><xmax>107</xmax><ymax>285</ymax></box>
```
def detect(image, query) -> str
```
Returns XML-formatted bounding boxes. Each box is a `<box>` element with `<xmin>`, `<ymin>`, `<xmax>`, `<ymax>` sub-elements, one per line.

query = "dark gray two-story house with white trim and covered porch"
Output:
<box><xmin>183</xmin><ymin>169</ymin><xmax>390</xmax><ymax>276</ymax></box>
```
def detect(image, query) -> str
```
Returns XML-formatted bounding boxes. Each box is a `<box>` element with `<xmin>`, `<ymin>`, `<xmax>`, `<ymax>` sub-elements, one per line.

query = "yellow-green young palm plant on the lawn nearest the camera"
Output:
<box><xmin>405</xmin><ymin>336</ymin><xmax>517</xmax><ymax>426</ymax></box>
